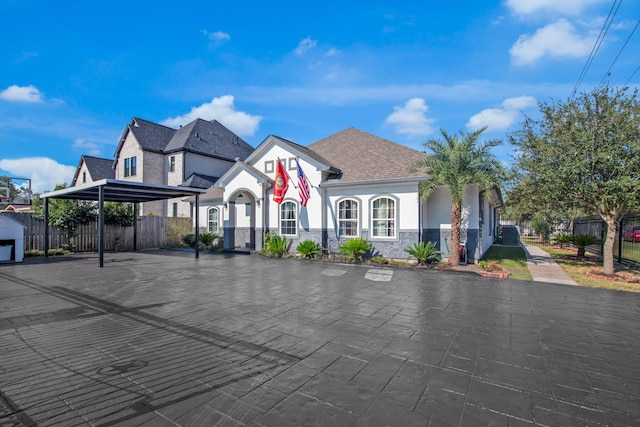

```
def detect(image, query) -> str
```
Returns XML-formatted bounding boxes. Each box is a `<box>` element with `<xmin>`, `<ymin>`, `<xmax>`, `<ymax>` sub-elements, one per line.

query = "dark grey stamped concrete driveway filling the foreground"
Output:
<box><xmin>0</xmin><ymin>251</ymin><xmax>640</xmax><ymax>427</ymax></box>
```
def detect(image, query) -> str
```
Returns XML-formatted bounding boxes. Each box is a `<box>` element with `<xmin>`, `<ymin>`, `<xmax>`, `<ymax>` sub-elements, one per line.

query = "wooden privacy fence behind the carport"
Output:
<box><xmin>7</xmin><ymin>212</ymin><xmax>191</xmax><ymax>252</ymax></box>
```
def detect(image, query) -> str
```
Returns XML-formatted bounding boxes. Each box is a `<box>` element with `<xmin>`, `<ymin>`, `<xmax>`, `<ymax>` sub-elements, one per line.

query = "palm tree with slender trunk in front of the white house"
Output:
<box><xmin>411</xmin><ymin>127</ymin><xmax>505</xmax><ymax>265</ymax></box>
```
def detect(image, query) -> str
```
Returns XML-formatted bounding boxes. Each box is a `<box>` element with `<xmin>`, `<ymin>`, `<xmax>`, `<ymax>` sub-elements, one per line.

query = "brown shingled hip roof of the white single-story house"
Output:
<box><xmin>307</xmin><ymin>127</ymin><xmax>427</xmax><ymax>183</ymax></box>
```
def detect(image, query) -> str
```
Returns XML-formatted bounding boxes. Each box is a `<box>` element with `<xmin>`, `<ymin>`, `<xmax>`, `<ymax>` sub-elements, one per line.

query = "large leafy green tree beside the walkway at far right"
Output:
<box><xmin>509</xmin><ymin>85</ymin><xmax>640</xmax><ymax>274</ymax></box>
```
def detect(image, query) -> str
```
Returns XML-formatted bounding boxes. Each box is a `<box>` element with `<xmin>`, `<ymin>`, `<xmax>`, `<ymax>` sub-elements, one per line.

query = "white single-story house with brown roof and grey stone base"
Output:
<box><xmin>192</xmin><ymin>128</ymin><xmax>502</xmax><ymax>260</ymax></box>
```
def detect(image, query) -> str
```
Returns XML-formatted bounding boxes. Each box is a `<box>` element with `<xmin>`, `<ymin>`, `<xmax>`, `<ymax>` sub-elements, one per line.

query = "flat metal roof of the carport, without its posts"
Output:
<box><xmin>40</xmin><ymin>179</ymin><xmax>206</xmax><ymax>203</ymax></box>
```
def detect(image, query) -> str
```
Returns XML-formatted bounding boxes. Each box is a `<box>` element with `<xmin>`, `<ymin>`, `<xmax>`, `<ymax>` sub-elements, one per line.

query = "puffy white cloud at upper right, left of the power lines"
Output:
<box><xmin>509</xmin><ymin>19</ymin><xmax>595</xmax><ymax>65</ymax></box>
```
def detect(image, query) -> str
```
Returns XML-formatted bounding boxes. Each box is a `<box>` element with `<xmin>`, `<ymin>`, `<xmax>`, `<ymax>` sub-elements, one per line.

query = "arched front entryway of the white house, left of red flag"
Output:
<box><xmin>224</xmin><ymin>190</ymin><xmax>256</xmax><ymax>250</ymax></box>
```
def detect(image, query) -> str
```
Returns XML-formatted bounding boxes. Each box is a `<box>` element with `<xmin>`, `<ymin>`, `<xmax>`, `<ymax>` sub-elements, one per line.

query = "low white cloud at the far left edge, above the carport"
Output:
<box><xmin>0</xmin><ymin>157</ymin><xmax>76</xmax><ymax>193</ymax></box>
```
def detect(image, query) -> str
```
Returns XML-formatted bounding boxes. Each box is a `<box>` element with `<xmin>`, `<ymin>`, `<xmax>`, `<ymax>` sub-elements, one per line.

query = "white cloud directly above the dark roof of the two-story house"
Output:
<box><xmin>160</xmin><ymin>95</ymin><xmax>262</xmax><ymax>136</ymax></box>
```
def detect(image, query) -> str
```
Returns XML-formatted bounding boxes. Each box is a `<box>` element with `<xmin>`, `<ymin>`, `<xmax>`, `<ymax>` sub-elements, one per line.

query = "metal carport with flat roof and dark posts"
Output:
<box><xmin>41</xmin><ymin>179</ymin><xmax>206</xmax><ymax>267</ymax></box>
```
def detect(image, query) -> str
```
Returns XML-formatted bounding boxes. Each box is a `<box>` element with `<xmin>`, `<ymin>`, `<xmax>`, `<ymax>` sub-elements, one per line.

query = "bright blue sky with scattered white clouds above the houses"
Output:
<box><xmin>0</xmin><ymin>0</ymin><xmax>640</xmax><ymax>192</ymax></box>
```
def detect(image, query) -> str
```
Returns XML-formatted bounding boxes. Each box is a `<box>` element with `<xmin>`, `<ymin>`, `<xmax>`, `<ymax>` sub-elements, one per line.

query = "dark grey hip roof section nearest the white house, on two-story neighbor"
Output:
<box><xmin>164</xmin><ymin>119</ymin><xmax>253</xmax><ymax>160</ymax></box>
